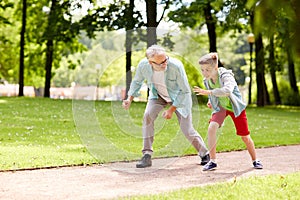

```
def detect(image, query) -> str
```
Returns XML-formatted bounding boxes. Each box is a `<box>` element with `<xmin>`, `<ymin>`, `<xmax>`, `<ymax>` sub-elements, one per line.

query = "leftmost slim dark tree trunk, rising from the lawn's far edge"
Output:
<box><xmin>19</xmin><ymin>0</ymin><xmax>27</xmax><ymax>97</ymax></box>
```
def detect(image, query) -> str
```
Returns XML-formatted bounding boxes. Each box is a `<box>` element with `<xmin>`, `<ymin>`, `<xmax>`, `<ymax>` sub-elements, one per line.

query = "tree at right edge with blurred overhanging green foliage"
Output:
<box><xmin>256</xmin><ymin>0</ymin><xmax>300</xmax><ymax>104</ymax></box>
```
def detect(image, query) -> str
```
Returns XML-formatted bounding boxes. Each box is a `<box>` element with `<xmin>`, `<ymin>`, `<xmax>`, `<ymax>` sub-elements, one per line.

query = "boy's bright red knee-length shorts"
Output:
<box><xmin>209</xmin><ymin>106</ymin><xmax>250</xmax><ymax>136</ymax></box>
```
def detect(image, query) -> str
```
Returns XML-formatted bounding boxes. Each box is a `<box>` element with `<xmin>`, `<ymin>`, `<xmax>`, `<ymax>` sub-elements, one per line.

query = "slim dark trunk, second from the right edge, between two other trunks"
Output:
<box><xmin>269</xmin><ymin>35</ymin><xmax>281</xmax><ymax>105</ymax></box>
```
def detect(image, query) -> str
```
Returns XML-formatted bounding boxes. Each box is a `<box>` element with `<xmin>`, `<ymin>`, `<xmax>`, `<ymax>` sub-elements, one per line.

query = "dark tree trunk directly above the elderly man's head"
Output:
<box><xmin>146</xmin><ymin>0</ymin><xmax>158</xmax><ymax>47</ymax></box>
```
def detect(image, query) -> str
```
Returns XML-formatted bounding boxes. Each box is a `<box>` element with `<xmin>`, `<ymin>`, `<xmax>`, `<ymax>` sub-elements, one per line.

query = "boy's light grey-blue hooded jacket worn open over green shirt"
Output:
<box><xmin>204</xmin><ymin>67</ymin><xmax>246</xmax><ymax>117</ymax></box>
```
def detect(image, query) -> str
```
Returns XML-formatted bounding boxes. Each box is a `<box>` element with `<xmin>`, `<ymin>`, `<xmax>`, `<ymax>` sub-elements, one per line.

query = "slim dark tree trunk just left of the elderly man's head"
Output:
<box><xmin>125</xmin><ymin>0</ymin><xmax>134</xmax><ymax>99</ymax></box>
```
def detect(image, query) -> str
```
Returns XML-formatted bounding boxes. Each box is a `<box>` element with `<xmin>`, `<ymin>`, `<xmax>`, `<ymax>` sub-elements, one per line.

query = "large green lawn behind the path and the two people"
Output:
<box><xmin>0</xmin><ymin>97</ymin><xmax>300</xmax><ymax>170</ymax></box>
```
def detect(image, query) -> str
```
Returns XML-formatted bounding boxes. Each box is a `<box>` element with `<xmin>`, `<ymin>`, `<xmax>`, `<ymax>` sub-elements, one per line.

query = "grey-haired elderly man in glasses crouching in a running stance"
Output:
<box><xmin>122</xmin><ymin>45</ymin><xmax>210</xmax><ymax>168</ymax></box>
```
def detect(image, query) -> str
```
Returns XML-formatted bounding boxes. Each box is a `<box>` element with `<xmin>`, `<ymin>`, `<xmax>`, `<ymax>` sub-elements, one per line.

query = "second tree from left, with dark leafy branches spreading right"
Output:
<box><xmin>43</xmin><ymin>0</ymin><xmax>116</xmax><ymax>97</ymax></box>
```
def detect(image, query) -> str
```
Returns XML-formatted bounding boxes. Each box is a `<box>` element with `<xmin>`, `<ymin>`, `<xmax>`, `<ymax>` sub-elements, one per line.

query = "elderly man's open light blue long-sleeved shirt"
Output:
<box><xmin>128</xmin><ymin>58</ymin><xmax>192</xmax><ymax>117</ymax></box>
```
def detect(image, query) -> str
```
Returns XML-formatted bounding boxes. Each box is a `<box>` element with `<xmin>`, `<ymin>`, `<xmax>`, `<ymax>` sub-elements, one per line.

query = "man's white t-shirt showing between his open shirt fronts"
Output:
<box><xmin>152</xmin><ymin>70</ymin><xmax>172</xmax><ymax>102</ymax></box>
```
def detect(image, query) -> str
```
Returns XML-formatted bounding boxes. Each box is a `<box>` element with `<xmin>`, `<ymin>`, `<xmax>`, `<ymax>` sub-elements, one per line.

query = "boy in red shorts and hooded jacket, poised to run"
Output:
<box><xmin>194</xmin><ymin>53</ymin><xmax>263</xmax><ymax>171</ymax></box>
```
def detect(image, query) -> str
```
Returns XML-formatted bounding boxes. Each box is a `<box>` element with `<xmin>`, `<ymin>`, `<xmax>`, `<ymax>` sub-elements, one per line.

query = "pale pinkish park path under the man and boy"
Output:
<box><xmin>0</xmin><ymin>145</ymin><xmax>300</xmax><ymax>200</ymax></box>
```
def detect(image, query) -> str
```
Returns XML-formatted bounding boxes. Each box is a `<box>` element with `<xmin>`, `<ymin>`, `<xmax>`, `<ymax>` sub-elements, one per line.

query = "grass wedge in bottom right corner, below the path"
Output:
<box><xmin>124</xmin><ymin>172</ymin><xmax>300</xmax><ymax>200</ymax></box>
